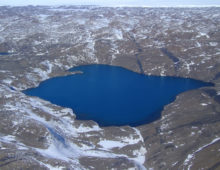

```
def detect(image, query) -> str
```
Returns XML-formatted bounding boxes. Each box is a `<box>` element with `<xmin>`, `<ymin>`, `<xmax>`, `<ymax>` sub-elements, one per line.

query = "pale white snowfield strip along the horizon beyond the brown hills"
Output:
<box><xmin>0</xmin><ymin>0</ymin><xmax>220</xmax><ymax>7</ymax></box>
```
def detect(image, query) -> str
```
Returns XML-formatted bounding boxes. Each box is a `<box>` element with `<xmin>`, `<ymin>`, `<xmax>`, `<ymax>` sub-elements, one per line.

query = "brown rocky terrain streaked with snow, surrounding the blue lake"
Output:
<box><xmin>0</xmin><ymin>6</ymin><xmax>220</xmax><ymax>170</ymax></box>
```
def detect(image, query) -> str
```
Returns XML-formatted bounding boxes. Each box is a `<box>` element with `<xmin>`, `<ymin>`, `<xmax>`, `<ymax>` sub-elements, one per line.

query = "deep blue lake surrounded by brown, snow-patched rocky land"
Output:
<box><xmin>24</xmin><ymin>65</ymin><xmax>211</xmax><ymax>126</ymax></box>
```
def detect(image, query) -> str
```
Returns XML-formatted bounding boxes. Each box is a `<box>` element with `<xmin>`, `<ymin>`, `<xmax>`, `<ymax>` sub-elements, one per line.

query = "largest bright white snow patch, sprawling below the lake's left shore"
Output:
<box><xmin>0</xmin><ymin>86</ymin><xmax>146</xmax><ymax>169</ymax></box>
